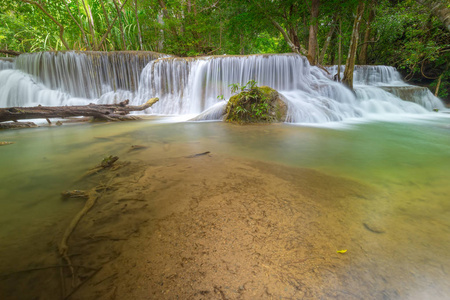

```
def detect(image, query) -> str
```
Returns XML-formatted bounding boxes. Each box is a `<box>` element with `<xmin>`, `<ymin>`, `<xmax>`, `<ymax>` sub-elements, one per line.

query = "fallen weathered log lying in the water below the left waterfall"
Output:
<box><xmin>0</xmin><ymin>98</ymin><xmax>159</xmax><ymax>122</ymax></box>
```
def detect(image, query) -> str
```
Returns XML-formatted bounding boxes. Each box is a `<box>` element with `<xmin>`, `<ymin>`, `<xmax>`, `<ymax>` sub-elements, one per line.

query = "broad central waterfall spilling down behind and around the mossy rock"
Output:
<box><xmin>135</xmin><ymin>54</ymin><xmax>362</xmax><ymax>122</ymax></box>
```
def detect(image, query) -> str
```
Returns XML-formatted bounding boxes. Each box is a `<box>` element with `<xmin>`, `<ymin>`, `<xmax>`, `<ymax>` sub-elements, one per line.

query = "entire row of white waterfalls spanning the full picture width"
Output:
<box><xmin>0</xmin><ymin>52</ymin><xmax>444</xmax><ymax>123</ymax></box>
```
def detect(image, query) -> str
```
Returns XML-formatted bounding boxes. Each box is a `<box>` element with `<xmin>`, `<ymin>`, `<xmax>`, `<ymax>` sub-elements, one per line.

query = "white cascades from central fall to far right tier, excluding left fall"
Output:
<box><xmin>138</xmin><ymin>54</ymin><xmax>444</xmax><ymax>123</ymax></box>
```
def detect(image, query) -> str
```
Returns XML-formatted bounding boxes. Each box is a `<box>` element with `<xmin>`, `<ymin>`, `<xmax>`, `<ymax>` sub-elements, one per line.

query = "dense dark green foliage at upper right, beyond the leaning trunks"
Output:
<box><xmin>371</xmin><ymin>0</ymin><xmax>450</xmax><ymax>98</ymax></box>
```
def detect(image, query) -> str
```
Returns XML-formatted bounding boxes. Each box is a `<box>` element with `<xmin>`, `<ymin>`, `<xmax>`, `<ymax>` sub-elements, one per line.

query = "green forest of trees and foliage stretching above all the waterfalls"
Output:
<box><xmin>0</xmin><ymin>0</ymin><xmax>450</xmax><ymax>98</ymax></box>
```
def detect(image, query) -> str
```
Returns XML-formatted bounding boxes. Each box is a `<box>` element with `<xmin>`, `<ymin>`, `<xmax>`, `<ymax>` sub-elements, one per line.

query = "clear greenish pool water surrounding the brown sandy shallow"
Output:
<box><xmin>0</xmin><ymin>115</ymin><xmax>450</xmax><ymax>299</ymax></box>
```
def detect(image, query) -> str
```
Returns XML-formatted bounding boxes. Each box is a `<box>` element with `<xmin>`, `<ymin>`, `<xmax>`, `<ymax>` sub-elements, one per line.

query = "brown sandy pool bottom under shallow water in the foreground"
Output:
<box><xmin>0</xmin><ymin>149</ymin><xmax>450</xmax><ymax>299</ymax></box>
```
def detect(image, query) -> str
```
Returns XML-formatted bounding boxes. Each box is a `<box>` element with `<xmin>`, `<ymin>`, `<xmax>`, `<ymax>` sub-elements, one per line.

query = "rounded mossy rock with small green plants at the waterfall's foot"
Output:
<box><xmin>225</xmin><ymin>86</ymin><xmax>287</xmax><ymax>124</ymax></box>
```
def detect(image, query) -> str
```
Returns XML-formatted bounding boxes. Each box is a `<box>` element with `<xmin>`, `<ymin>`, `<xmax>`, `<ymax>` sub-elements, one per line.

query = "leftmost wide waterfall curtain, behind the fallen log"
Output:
<box><xmin>0</xmin><ymin>51</ymin><xmax>168</xmax><ymax>107</ymax></box>
